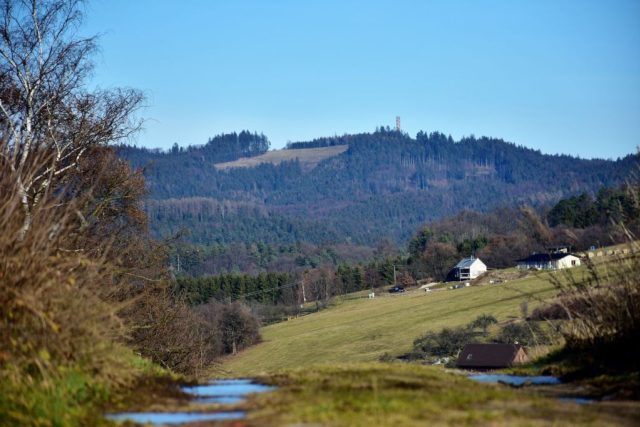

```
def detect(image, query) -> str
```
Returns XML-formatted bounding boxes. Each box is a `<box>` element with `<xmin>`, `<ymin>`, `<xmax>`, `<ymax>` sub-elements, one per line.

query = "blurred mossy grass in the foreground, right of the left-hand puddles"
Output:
<box><xmin>245</xmin><ymin>363</ymin><xmax>640</xmax><ymax>427</ymax></box>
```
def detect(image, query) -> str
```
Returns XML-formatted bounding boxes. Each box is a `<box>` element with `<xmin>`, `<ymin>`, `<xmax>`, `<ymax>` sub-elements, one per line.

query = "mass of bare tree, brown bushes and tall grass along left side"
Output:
<box><xmin>0</xmin><ymin>0</ymin><xmax>258</xmax><ymax>425</ymax></box>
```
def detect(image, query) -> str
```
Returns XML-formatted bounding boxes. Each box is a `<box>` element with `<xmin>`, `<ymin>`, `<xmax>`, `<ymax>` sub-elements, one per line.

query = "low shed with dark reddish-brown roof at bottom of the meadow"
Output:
<box><xmin>456</xmin><ymin>344</ymin><xmax>528</xmax><ymax>369</ymax></box>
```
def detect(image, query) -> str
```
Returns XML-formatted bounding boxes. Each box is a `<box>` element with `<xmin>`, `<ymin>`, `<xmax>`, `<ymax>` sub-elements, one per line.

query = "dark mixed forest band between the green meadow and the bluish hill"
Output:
<box><xmin>175</xmin><ymin>186</ymin><xmax>640</xmax><ymax>310</ymax></box>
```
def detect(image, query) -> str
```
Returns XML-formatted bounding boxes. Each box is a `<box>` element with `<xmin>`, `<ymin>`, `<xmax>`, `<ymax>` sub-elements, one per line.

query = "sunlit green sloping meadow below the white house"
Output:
<box><xmin>219</xmin><ymin>268</ymin><xmax>564</xmax><ymax>376</ymax></box>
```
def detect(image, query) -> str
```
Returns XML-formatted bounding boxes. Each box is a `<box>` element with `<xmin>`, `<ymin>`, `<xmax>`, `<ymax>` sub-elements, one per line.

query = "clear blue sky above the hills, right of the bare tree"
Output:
<box><xmin>83</xmin><ymin>0</ymin><xmax>640</xmax><ymax>158</ymax></box>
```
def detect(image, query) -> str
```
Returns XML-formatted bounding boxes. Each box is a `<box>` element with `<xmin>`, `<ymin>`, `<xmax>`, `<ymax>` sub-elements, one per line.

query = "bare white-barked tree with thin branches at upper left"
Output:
<box><xmin>0</xmin><ymin>0</ymin><xmax>142</xmax><ymax>236</ymax></box>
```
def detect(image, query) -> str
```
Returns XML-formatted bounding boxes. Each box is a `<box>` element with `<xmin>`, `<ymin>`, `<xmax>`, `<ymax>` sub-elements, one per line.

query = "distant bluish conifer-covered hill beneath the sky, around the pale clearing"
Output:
<box><xmin>119</xmin><ymin>129</ymin><xmax>638</xmax><ymax>245</ymax></box>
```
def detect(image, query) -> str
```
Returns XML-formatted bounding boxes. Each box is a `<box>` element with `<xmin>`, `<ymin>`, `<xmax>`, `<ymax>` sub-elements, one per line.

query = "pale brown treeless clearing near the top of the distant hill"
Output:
<box><xmin>215</xmin><ymin>145</ymin><xmax>349</xmax><ymax>170</ymax></box>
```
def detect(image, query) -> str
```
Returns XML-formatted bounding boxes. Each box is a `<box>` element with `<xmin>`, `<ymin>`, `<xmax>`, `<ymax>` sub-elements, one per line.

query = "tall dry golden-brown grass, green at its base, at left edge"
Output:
<box><xmin>0</xmin><ymin>150</ymin><xmax>161</xmax><ymax>425</ymax></box>
